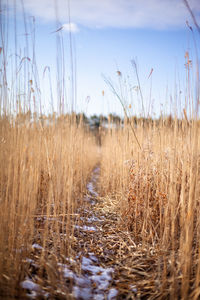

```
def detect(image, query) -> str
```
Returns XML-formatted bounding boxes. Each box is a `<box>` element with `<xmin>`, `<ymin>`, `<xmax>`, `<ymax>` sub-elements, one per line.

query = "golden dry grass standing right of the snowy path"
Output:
<box><xmin>101</xmin><ymin>121</ymin><xmax>200</xmax><ymax>299</ymax></box>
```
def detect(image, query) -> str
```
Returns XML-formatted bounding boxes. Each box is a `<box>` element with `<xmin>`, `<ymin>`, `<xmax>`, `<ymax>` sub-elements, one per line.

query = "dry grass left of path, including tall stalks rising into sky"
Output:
<box><xmin>0</xmin><ymin>1</ymin><xmax>99</xmax><ymax>299</ymax></box>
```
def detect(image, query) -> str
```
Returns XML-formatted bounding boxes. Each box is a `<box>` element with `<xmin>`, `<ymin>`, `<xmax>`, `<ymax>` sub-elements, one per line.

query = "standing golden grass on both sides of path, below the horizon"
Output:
<box><xmin>0</xmin><ymin>111</ymin><xmax>200</xmax><ymax>299</ymax></box>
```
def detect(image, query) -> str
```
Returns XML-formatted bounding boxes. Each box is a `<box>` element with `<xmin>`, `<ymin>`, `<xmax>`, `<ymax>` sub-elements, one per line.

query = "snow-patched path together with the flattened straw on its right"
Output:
<box><xmin>65</xmin><ymin>167</ymin><xmax>158</xmax><ymax>300</ymax></box>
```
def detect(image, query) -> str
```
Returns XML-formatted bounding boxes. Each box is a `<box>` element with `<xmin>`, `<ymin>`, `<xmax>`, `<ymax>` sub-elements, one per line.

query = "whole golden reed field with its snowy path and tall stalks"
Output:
<box><xmin>0</xmin><ymin>1</ymin><xmax>200</xmax><ymax>300</ymax></box>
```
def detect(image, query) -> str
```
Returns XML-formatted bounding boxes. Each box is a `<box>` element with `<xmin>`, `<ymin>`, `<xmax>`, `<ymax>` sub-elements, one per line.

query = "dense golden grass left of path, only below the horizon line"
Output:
<box><xmin>0</xmin><ymin>115</ymin><xmax>98</xmax><ymax>297</ymax></box>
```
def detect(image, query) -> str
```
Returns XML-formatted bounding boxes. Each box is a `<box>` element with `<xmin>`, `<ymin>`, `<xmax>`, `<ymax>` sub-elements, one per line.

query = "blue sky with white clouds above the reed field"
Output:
<box><xmin>3</xmin><ymin>0</ymin><xmax>200</xmax><ymax>115</ymax></box>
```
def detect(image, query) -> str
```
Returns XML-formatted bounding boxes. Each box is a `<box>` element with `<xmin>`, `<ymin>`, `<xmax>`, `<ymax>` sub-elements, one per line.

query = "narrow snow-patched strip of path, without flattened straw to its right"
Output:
<box><xmin>61</xmin><ymin>167</ymin><xmax>118</xmax><ymax>300</ymax></box>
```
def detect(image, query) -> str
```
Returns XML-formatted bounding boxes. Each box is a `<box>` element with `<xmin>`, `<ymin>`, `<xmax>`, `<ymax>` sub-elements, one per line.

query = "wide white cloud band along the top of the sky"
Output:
<box><xmin>3</xmin><ymin>0</ymin><xmax>200</xmax><ymax>31</ymax></box>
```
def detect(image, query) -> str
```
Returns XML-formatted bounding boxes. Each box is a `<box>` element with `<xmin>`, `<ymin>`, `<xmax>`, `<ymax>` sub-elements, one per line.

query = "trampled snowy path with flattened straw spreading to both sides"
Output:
<box><xmin>20</xmin><ymin>167</ymin><xmax>160</xmax><ymax>300</ymax></box>
